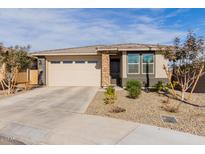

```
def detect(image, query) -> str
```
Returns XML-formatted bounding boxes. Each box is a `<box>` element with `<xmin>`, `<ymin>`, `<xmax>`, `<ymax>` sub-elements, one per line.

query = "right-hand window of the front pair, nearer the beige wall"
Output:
<box><xmin>142</xmin><ymin>54</ymin><xmax>154</xmax><ymax>74</ymax></box>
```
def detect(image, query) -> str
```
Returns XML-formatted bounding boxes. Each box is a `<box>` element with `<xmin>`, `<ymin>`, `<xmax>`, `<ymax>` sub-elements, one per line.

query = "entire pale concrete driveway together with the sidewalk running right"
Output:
<box><xmin>0</xmin><ymin>87</ymin><xmax>205</xmax><ymax>144</ymax></box>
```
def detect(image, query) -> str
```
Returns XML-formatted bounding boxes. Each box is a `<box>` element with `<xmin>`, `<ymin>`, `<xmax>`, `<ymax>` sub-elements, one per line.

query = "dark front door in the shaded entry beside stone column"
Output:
<box><xmin>110</xmin><ymin>59</ymin><xmax>120</xmax><ymax>85</ymax></box>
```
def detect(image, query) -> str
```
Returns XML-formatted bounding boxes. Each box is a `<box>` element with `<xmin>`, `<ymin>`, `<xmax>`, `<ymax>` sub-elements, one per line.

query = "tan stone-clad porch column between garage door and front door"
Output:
<box><xmin>101</xmin><ymin>52</ymin><xmax>110</xmax><ymax>87</ymax></box>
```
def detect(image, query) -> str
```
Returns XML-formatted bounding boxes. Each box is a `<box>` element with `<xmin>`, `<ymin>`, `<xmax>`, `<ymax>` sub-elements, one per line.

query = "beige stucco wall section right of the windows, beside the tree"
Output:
<box><xmin>155</xmin><ymin>54</ymin><xmax>168</xmax><ymax>78</ymax></box>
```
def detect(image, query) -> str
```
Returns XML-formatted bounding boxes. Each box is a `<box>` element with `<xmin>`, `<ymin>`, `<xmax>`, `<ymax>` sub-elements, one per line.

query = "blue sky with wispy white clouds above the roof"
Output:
<box><xmin>0</xmin><ymin>9</ymin><xmax>205</xmax><ymax>51</ymax></box>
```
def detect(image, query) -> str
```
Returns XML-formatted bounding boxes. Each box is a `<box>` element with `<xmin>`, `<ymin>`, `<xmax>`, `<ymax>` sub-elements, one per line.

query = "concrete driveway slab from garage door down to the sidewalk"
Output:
<box><xmin>0</xmin><ymin>87</ymin><xmax>97</xmax><ymax>114</ymax></box>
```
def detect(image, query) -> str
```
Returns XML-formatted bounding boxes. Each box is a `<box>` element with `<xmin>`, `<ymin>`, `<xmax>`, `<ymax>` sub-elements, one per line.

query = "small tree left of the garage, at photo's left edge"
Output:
<box><xmin>0</xmin><ymin>44</ymin><xmax>32</xmax><ymax>94</ymax></box>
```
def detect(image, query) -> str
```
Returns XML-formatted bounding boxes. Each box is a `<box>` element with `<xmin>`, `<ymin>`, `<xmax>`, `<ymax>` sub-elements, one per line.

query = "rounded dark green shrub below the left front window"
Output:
<box><xmin>126</xmin><ymin>80</ymin><xmax>142</xmax><ymax>98</ymax></box>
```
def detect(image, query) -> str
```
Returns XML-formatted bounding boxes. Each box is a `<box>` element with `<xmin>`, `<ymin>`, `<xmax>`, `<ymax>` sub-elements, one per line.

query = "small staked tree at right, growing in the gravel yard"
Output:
<box><xmin>162</xmin><ymin>32</ymin><xmax>204</xmax><ymax>101</ymax></box>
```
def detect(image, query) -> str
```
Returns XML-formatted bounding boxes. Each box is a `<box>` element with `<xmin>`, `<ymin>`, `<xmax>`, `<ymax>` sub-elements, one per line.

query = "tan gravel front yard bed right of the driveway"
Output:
<box><xmin>86</xmin><ymin>90</ymin><xmax>205</xmax><ymax>136</ymax></box>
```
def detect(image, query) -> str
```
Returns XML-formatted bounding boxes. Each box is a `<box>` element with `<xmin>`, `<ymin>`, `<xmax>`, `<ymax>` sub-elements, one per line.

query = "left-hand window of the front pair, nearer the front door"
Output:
<box><xmin>128</xmin><ymin>54</ymin><xmax>140</xmax><ymax>74</ymax></box>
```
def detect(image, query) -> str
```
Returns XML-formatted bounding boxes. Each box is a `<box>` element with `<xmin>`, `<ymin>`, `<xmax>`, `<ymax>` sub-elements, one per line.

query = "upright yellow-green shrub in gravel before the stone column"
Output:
<box><xmin>104</xmin><ymin>86</ymin><xmax>117</xmax><ymax>104</ymax></box>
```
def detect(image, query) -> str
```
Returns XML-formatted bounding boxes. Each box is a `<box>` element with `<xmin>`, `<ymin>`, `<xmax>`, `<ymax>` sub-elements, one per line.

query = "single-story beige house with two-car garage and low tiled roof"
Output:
<box><xmin>31</xmin><ymin>44</ymin><xmax>168</xmax><ymax>87</ymax></box>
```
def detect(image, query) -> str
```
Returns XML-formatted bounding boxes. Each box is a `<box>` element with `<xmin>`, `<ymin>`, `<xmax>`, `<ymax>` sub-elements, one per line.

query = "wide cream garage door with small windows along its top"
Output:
<box><xmin>48</xmin><ymin>57</ymin><xmax>101</xmax><ymax>86</ymax></box>
